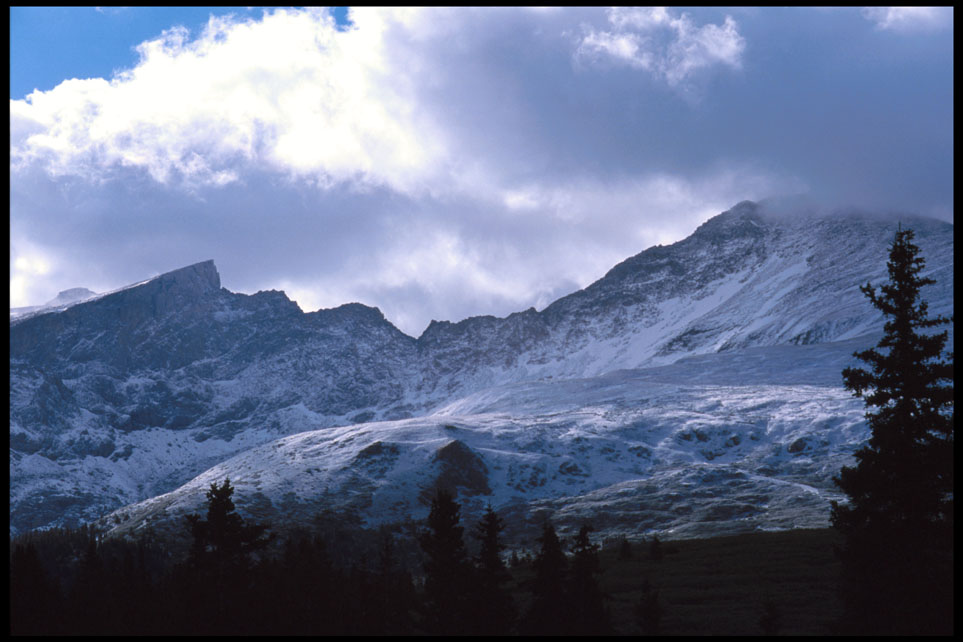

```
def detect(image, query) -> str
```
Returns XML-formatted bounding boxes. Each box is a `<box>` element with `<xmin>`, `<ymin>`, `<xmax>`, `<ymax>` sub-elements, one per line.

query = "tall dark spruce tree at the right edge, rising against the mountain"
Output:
<box><xmin>831</xmin><ymin>229</ymin><xmax>953</xmax><ymax>634</ymax></box>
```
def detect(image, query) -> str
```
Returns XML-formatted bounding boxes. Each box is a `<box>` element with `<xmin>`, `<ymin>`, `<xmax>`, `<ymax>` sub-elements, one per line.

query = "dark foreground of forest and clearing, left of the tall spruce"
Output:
<box><xmin>10</xmin><ymin>480</ymin><xmax>852</xmax><ymax>635</ymax></box>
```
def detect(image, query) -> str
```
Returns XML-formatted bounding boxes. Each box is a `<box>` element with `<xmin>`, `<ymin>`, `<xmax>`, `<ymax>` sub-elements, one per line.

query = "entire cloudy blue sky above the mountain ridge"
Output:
<box><xmin>10</xmin><ymin>7</ymin><xmax>953</xmax><ymax>337</ymax></box>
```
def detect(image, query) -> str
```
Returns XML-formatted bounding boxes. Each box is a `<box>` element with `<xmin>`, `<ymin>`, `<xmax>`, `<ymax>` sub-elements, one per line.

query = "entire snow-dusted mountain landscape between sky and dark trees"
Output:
<box><xmin>10</xmin><ymin>201</ymin><xmax>953</xmax><ymax>541</ymax></box>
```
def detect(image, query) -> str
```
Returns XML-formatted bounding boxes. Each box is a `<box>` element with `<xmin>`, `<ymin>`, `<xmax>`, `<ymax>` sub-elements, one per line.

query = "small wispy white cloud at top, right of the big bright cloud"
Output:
<box><xmin>576</xmin><ymin>7</ymin><xmax>746</xmax><ymax>87</ymax></box>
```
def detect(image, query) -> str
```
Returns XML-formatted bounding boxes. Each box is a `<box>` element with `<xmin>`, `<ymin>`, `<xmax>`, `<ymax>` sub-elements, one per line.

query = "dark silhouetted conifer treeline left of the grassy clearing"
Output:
<box><xmin>10</xmin><ymin>480</ymin><xmax>610</xmax><ymax>635</ymax></box>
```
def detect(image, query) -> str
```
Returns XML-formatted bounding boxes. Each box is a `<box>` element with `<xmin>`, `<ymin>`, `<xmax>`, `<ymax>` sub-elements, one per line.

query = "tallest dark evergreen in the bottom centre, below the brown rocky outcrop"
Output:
<box><xmin>419</xmin><ymin>488</ymin><xmax>472</xmax><ymax>635</ymax></box>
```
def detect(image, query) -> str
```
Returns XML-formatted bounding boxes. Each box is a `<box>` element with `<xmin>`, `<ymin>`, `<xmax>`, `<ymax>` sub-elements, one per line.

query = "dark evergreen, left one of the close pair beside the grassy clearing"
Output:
<box><xmin>522</xmin><ymin>521</ymin><xmax>571</xmax><ymax>635</ymax></box>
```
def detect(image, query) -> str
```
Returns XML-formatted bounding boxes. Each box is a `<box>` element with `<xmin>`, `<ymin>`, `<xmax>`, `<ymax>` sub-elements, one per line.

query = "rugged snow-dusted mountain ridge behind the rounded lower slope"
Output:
<box><xmin>10</xmin><ymin>202</ymin><xmax>953</xmax><ymax>529</ymax></box>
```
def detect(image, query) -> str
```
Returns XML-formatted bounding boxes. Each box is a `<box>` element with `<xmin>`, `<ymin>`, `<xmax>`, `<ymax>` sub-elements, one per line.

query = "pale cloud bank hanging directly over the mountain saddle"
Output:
<box><xmin>258</xmin><ymin>163</ymin><xmax>805</xmax><ymax>336</ymax></box>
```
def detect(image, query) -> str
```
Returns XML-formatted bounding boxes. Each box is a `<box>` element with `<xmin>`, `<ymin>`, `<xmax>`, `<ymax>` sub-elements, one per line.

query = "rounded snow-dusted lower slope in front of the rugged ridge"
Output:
<box><xmin>103</xmin><ymin>339</ymin><xmax>867</xmax><ymax>543</ymax></box>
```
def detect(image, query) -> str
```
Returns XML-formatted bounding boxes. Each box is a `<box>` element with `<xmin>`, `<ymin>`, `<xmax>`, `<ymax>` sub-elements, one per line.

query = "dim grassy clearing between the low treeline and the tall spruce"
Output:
<box><xmin>514</xmin><ymin>529</ymin><xmax>840</xmax><ymax>635</ymax></box>
